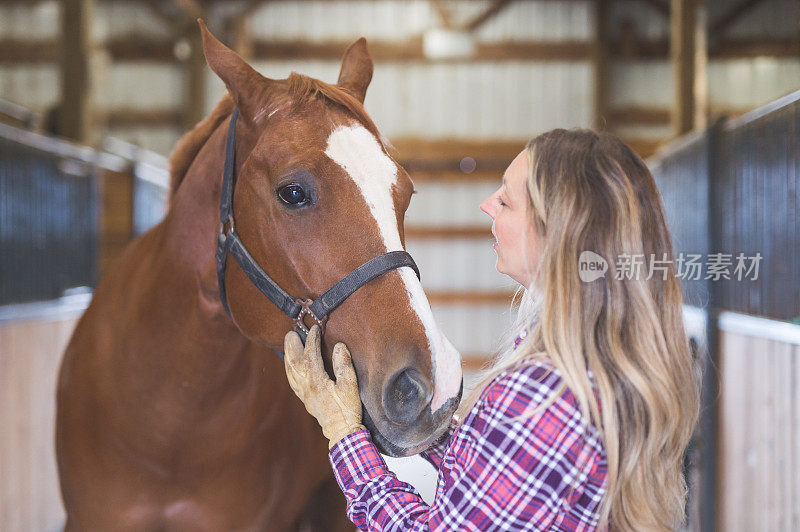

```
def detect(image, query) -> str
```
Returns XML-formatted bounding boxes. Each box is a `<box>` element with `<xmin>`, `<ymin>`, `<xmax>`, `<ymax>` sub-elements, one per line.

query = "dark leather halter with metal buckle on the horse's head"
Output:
<box><xmin>216</xmin><ymin>108</ymin><xmax>419</xmax><ymax>350</ymax></box>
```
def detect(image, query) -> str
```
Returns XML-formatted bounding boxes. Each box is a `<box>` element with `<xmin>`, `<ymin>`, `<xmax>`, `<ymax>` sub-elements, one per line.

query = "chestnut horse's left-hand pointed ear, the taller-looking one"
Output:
<box><xmin>197</xmin><ymin>19</ymin><xmax>270</xmax><ymax>120</ymax></box>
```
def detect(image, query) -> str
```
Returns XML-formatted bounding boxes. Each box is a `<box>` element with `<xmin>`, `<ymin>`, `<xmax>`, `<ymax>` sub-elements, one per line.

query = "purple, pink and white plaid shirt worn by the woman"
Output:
<box><xmin>329</xmin><ymin>334</ymin><xmax>607</xmax><ymax>531</ymax></box>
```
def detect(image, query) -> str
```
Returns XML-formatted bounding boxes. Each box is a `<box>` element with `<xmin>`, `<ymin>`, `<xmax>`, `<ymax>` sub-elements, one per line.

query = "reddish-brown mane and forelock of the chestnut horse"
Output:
<box><xmin>169</xmin><ymin>72</ymin><xmax>391</xmax><ymax>200</ymax></box>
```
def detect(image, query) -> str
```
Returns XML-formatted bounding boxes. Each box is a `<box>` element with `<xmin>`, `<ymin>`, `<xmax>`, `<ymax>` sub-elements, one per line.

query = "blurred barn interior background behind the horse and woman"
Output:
<box><xmin>0</xmin><ymin>0</ymin><xmax>800</xmax><ymax>532</ymax></box>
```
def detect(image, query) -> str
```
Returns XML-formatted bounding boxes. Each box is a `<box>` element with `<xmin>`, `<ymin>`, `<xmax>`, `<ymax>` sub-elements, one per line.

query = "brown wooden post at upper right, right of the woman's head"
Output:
<box><xmin>670</xmin><ymin>0</ymin><xmax>697</xmax><ymax>136</ymax></box>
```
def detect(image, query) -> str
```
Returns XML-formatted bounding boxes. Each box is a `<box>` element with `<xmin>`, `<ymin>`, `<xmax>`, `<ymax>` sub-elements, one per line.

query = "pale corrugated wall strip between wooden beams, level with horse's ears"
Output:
<box><xmin>207</xmin><ymin>61</ymin><xmax>592</xmax><ymax>140</ymax></box>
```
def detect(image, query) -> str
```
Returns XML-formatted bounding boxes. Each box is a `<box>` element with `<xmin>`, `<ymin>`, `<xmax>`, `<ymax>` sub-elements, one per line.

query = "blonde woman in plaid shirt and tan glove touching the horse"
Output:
<box><xmin>285</xmin><ymin>129</ymin><xmax>699</xmax><ymax>532</ymax></box>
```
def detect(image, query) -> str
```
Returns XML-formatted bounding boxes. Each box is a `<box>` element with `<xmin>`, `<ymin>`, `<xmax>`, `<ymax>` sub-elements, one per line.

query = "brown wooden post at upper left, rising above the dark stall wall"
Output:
<box><xmin>57</xmin><ymin>0</ymin><xmax>94</xmax><ymax>144</ymax></box>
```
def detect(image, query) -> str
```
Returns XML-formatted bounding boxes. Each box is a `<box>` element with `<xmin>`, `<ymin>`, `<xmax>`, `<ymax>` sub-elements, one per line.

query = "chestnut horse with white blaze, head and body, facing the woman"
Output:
<box><xmin>56</xmin><ymin>24</ymin><xmax>461</xmax><ymax>531</ymax></box>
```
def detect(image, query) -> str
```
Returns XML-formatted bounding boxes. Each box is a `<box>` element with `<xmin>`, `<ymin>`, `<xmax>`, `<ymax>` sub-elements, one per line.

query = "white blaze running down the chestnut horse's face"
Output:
<box><xmin>325</xmin><ymin>125</ymin><xmax>461</xmax><ymax>412</ymax></box>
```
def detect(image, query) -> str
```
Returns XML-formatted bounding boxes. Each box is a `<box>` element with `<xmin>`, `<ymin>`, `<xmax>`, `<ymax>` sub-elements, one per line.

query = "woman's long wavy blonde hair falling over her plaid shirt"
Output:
<box><xmin>458</xmin><ymin>129</ymin><xmax>700</xmax><ymax>531</ymax></box>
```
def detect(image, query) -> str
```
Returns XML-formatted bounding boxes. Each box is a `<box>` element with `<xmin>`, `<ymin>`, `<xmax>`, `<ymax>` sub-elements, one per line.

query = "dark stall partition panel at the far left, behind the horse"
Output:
<box><xmin>0</xmin><ymin>124</ymin><xmax>100</xmax><ymax>305</ymax></box>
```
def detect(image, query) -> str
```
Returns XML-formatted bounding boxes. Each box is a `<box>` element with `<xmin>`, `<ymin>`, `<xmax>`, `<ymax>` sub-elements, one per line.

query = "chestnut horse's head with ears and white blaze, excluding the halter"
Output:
<box><xmin>201</xmin><ymin>23</ymin><xmax>462</xmax><ymax>456</ymax></box>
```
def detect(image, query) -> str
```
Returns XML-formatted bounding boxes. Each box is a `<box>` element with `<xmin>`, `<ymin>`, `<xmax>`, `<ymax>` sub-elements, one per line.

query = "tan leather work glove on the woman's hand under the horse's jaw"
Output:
<box><xmin>283</xmin><ymin>325</ymin><xmax>365</xmax><ymax>449</ymax></box>
